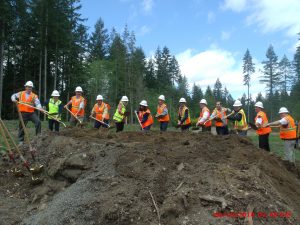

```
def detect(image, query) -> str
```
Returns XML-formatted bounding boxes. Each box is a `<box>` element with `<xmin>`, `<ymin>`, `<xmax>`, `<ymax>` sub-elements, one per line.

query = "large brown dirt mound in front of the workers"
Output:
<box><xmin>0</xmin><ymin>129</ymin><xmax>300</xmax><ymax>225</ymax></box>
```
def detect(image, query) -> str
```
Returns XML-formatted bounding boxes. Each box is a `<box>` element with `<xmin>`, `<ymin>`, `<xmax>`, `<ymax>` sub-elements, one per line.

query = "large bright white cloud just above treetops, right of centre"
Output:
<box><xmin>176</xmin><ymin>47</ymin><xmax>264</xmax><ymax>98</ymax></box>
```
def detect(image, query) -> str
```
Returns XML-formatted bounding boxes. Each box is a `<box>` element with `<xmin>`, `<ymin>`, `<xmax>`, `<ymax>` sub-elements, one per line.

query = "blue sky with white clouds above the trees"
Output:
<box><xmin>81</xmin><ymin>0</ymin><xmax>300</xmax><ymax>98</ymax></box>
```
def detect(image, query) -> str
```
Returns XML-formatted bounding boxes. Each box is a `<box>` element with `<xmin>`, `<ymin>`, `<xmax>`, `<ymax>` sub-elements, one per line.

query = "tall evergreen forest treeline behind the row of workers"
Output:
<box><xmin>0</xmin><ymin>0</ymin><xmax>300</xmax><ymax>122</ymax></box>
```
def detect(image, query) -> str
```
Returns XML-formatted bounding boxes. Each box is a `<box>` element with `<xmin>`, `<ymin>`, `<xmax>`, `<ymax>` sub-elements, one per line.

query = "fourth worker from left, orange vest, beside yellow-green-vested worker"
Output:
<box><xmin>91</xmin><ymin>95</ymin><xmax>110</xmax><ymax>128</ymax></box>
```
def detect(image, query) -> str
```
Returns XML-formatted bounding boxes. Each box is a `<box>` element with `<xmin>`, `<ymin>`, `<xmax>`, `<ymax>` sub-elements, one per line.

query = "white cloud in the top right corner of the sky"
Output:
<box><xmin>222</xmin><ymin>0</ymin><xmax>300</xmax><ymax>37</ymax></box>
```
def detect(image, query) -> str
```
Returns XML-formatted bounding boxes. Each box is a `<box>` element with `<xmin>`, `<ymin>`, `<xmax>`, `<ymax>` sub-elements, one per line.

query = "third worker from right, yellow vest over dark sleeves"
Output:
<box><xmin>227</xmin><ymin>100</ymin><xmax>248</xmax><ymax>136</ymax></box>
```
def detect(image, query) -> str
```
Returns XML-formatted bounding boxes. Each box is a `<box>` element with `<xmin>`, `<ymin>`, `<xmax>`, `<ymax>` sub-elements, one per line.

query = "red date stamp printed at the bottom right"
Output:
<box><xmin>212</xmin><ymin>211</ymin><xmax>292</xmax><ymax>218</ymax></box>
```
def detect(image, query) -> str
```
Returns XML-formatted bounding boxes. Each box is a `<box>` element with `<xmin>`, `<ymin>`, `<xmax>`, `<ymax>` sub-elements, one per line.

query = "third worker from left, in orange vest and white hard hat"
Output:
<box><xmin>64</xmin><ymin>86</ymin><xmax>86</xmax><ymax>126</ymax></box>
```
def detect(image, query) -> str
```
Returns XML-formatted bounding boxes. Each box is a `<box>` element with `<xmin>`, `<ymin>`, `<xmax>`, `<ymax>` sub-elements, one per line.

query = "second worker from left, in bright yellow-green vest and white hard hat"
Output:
<box><xmin>45</xmin><ymin>90</ymin><xmax>63</xmax><ymax>132</ymax></box>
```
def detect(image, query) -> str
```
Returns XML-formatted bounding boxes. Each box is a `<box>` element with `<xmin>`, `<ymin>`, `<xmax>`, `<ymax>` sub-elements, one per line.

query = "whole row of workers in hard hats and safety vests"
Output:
<box><xmin>11</xmin><ymin>81</ymin><xmax>299</xmax><ymax>162</ymax></box>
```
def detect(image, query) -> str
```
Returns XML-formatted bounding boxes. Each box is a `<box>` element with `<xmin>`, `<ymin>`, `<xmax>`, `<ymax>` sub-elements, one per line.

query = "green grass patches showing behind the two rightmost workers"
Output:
<box><xmin>248</xmin><ymin>132</ymin><xmax>300</xmax><ymax>161</ymax></box>
